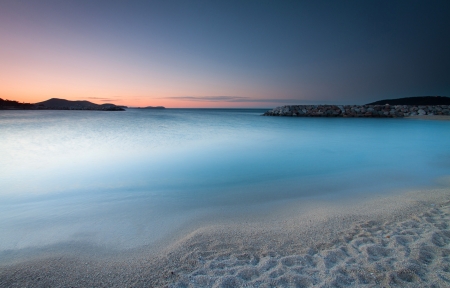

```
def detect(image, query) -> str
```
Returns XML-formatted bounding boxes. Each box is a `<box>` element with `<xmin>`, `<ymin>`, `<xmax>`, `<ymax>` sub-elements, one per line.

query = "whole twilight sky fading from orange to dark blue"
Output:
<box><xmin>0</xmin><ymin>0</ymin><xmax>450</xmax><ymax>108</ymax></box>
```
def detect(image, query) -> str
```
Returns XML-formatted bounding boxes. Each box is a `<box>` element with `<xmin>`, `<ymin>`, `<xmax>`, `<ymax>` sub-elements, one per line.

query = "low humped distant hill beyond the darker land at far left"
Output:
<box><xmin>34</xmin><ymin>98</ymin><xmax>125</xmax><ymax>111</ymax></box>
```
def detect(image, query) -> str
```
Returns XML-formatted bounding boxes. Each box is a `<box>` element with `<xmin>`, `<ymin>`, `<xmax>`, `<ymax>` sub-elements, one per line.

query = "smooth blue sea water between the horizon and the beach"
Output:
<box><xmin>0</xmin><ymin>109</ymin><xmax>450</xmax><ymax>252</ymax></box>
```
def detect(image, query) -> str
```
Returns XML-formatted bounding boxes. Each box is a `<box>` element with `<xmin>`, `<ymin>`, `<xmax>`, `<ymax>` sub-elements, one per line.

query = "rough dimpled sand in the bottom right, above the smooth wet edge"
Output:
<box><xmin>169</xmin><ymin>203</ymin><xmax>450</xmax><ymax>287</ymax></box>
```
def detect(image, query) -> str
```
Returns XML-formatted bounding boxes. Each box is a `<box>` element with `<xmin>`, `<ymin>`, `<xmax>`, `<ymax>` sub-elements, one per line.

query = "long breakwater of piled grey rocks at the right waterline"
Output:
<box><xmin>263</xmin><ymin>104</ymin><xmax>450</xmax><ymax>118</ymax></box>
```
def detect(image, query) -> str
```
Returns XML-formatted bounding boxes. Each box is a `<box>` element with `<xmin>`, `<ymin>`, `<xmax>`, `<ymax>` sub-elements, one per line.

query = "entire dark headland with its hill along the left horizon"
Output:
<box><xmin>0</xmin><ymin>98</ymin><xmax>127</xmax><ymax>111</ymax></box>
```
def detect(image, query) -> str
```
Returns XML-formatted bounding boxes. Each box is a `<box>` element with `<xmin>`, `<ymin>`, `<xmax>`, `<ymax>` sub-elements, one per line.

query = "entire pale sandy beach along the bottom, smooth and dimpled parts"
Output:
<box><xmin>0</xmin><ymin>183</ymin><xmax>450</xmax><ymax>287</ymax></box>
